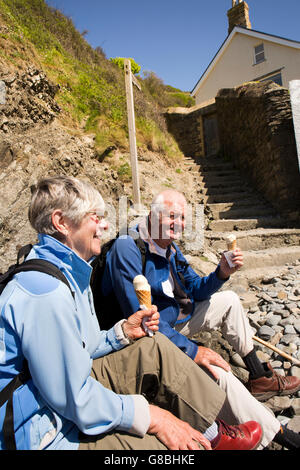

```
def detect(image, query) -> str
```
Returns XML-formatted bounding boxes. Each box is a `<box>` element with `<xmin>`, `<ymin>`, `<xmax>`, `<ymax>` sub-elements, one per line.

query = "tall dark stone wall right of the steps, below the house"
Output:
<box><xmin>216</xmin><ymin>81</ymin><xmax>300</xmax><ymax>218</ymax></box>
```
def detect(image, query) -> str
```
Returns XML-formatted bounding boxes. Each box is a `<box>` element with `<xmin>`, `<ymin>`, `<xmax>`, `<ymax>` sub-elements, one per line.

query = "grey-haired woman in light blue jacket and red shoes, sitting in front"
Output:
<box><xmin>0</xmin><ymin>176</ymin><xmax>261</xmax><ymax>450</ymax></box>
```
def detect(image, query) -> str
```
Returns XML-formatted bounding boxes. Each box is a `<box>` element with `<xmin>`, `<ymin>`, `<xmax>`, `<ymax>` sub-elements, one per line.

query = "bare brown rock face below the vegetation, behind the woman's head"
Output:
<box><xmin>0</xmin><ymin>67</ymin><xmax>205</xmax><ymax>272</ymax></box>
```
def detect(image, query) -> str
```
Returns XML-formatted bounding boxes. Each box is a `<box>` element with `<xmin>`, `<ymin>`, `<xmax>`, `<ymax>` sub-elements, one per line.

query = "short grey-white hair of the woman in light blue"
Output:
<box><xmin>28</xmin><ymin>176</ymin><xmax>105</xmax><ymax>236</ymax></box>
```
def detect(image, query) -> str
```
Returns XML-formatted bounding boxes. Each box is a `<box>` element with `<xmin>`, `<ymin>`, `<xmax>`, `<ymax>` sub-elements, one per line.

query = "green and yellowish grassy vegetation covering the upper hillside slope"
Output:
<box><xmin>0</xmin><ymin>0</ymin><xmax>193</xmax><ymax>158</ymax></box>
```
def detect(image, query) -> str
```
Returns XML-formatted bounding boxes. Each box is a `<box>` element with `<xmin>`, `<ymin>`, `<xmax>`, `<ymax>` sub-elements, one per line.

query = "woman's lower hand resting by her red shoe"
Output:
<box><xmin>148</xmin><ymin>405</ymin><xmax>211</xmax><ymax>450</ymax></box>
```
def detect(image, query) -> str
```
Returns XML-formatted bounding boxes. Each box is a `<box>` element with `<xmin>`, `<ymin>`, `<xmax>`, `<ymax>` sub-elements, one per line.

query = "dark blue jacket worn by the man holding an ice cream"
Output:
<box><xmin>102</xmin><ymin>227</ymin><xmax>224</xmax><ymax>359</ymax></box>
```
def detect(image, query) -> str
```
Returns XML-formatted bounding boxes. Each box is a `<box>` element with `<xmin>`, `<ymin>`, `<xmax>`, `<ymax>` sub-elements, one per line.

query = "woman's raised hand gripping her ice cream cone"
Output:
<box><xmin>122</xmin><ymin>305</ymin><xmax>159</xmax><ymax>339</ymax></box>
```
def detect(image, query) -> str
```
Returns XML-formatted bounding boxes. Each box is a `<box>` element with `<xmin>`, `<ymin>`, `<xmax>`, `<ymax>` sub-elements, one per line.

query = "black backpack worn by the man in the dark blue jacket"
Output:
<box><xmin>91</xmin><ymin>234</ymin><xmax>146</xmax><ymax>330</ymax></box>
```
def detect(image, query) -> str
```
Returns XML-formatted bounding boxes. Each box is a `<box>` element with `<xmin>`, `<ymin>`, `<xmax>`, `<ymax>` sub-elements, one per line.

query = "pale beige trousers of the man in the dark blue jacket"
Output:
<box><xmin>176</xmin><ymin>291</ymin><xmax>280</xmax><ymax>448</ymax></box>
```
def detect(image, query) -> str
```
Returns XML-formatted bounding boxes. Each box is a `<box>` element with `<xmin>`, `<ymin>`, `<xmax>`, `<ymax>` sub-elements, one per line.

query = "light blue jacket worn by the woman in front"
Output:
<box><xmin>0</xmin><ymin>235</ymin><xmax>150</xmax><ymax>450</ymax></box>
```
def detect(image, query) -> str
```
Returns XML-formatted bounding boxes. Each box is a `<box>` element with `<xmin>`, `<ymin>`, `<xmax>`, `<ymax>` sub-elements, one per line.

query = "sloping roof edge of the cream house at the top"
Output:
<box><xmin>191</xmin><ymin>26</ymin><xmax>300</xmax><ymax>96</ymax></box>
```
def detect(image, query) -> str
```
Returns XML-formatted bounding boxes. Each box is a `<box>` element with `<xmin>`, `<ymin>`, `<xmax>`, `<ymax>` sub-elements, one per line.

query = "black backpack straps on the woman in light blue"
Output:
<box><xmin>0</xmin><ymin>245</ymin><xmax>74</xmax><ymax>450</ymax></box>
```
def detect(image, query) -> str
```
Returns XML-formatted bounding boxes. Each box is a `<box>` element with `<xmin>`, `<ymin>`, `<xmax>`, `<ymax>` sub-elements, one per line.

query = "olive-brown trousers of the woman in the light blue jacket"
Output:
<box><xmin>79</xmin><ymin>333</ymin><xmax>226</xmax><ymax>450</ymax></box>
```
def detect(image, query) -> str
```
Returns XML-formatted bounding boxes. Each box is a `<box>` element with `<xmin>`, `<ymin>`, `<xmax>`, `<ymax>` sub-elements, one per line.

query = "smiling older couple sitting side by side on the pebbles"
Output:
<box><xmin>0</xmin><ymin>176</ymin><xmax>300</xmax><ymax>451</ymax></box>
